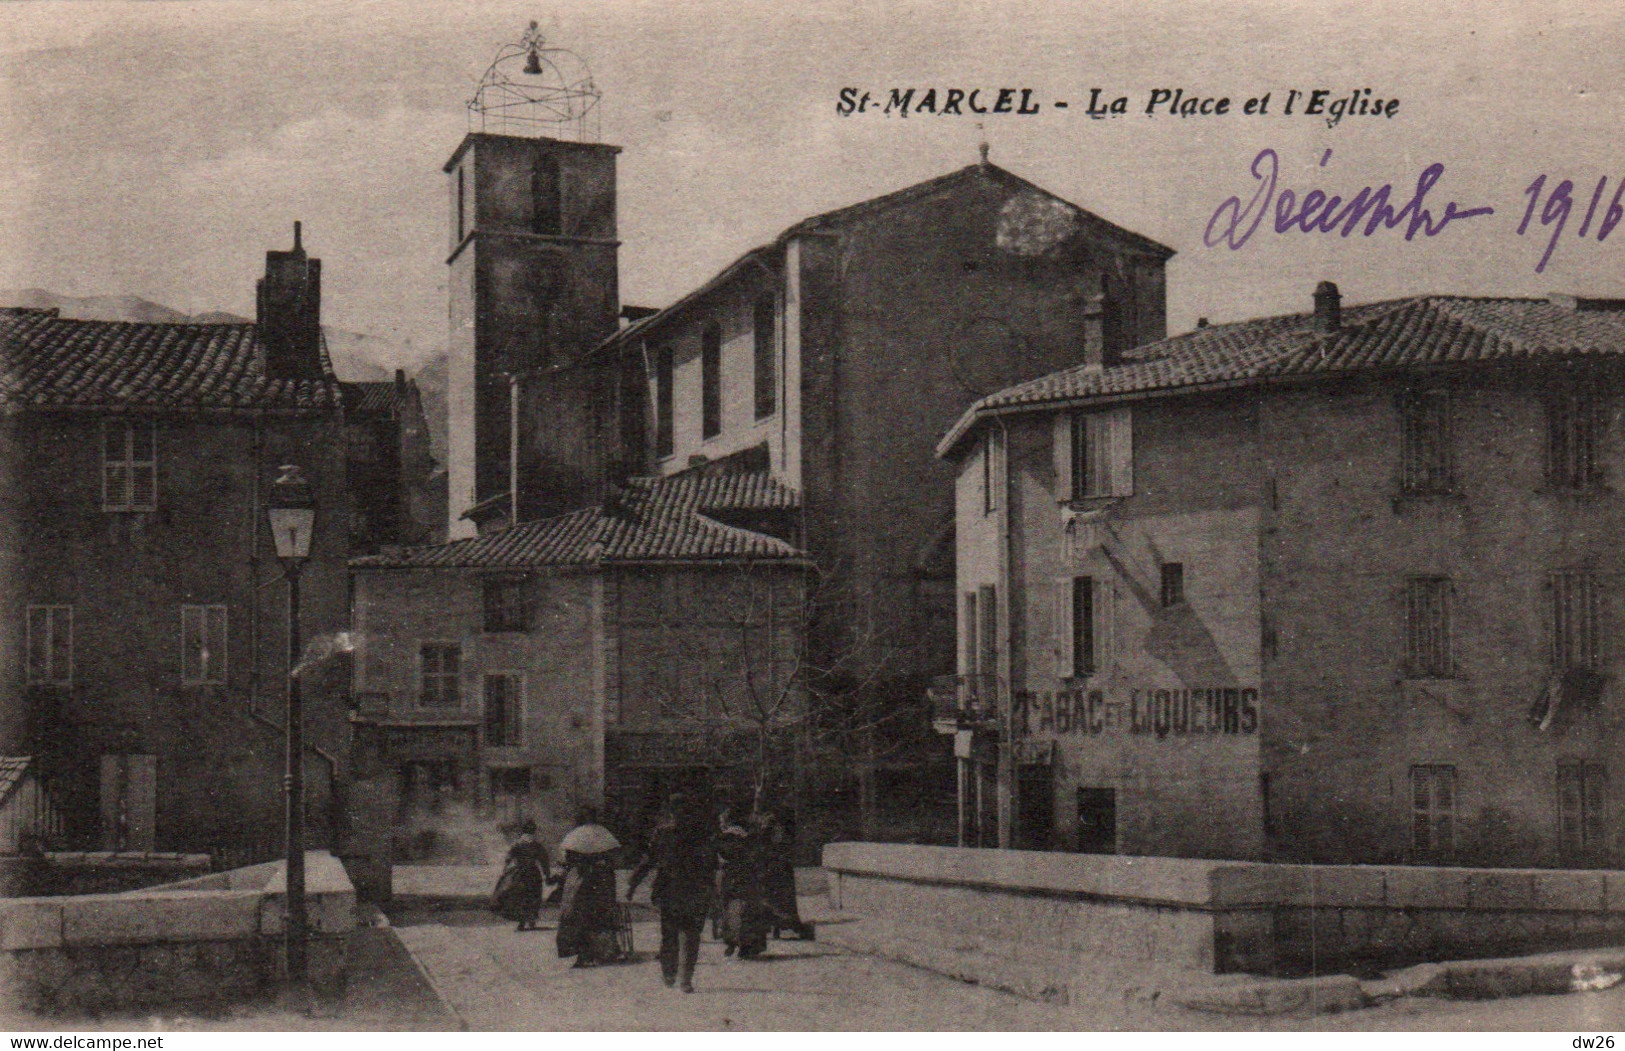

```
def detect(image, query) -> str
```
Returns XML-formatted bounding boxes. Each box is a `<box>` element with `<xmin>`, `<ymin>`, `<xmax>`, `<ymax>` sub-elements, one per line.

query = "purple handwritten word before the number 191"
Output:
<box><xmin>1203</xmin><ymin>149</ymin><xmax>1495</xmax><ymax>250</ymax></box>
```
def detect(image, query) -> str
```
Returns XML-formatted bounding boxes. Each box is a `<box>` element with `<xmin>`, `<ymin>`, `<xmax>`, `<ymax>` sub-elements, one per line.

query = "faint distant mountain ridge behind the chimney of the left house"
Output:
<box><xmin>0</xmin><ymin>288</ymin><xmax>447</xmax><ymax>463</ymax></box>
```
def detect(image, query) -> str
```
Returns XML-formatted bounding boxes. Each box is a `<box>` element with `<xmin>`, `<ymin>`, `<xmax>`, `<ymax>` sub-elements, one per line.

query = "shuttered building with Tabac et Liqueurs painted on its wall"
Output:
<box><xmin>939</xmin><ymin>283</ymin><xmax>1625</xmax><ymax>867</ymax></box>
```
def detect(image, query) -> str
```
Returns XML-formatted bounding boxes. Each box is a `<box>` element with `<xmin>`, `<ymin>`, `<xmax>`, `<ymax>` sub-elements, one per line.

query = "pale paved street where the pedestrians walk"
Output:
<box><xmin>383</xmin><ymin>913</ymin><xmax>1625</xmax><ymax>1032</ymax></box>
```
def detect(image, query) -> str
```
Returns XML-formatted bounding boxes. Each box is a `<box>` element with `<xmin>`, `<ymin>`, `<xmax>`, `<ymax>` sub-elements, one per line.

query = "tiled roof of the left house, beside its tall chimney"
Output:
<box><xmin>0</xmin><ymin>310</ymin><xmax>340</xmax><ymax>413</ymax></box>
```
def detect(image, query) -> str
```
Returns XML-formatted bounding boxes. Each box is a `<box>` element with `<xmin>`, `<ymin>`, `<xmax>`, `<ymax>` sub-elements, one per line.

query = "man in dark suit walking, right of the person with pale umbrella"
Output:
<box><xmin>626</xmin><ymin>793</ymin><xmax>717</xmax><ymax>993</ymax></box>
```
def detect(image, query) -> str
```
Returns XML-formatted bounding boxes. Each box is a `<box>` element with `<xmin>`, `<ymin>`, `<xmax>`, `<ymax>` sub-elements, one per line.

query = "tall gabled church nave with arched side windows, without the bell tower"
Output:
<box><xmin>593</xmin><ymin>158</ymin><xmax>1173</xmax><ymax>841</ymax></box>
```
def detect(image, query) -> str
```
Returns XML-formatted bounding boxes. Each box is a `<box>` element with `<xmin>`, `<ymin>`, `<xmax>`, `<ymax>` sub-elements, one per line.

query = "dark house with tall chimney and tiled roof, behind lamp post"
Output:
<box><xmin>0</xmin><ymin>226</ymin><xmax>349</xmax><ymax>859</ymax></box>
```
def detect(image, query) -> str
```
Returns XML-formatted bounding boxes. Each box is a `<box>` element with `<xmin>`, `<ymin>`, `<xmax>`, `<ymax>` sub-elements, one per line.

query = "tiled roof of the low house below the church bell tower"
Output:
<box><xmin>351</xmin><ymin>476</ymin><xmax>801</xmax><ymax>569</ymax></box>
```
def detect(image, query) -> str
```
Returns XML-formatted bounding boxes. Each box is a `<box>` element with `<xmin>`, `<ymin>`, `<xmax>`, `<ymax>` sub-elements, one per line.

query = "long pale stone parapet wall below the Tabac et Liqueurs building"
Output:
<box><xmin>824</xmin><ymin>843</ymin><xmax>1625</xmax><ymax>999</ymax></box>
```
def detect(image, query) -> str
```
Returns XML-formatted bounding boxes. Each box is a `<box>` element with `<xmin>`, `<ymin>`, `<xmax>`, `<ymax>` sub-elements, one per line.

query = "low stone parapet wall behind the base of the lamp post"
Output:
<box><xmin>0</xmin><ymin>853</ymin><xmax>356</xmax><ymax>1012</ymax></box>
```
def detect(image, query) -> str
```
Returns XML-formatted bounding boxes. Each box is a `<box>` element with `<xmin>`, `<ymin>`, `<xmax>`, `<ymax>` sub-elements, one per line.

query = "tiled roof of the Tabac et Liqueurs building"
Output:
<box><xmin>938</xmin><ymin>296</ymin><xmax>1625</xmax><ymax>453</ymax></box>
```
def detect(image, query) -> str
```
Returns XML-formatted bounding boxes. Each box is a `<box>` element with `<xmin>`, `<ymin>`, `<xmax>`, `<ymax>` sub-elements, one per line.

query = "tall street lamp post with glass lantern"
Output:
<box><xmin>265</xmin><ymin>465</ymin><xmax>315</xmax><ymax>981</ymax></box>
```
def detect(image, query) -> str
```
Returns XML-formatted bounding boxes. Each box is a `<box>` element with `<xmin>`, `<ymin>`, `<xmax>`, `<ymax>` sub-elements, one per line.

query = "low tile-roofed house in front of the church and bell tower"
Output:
<box><xmin>348</xmin><ymin>474</ymin><xmax>808</xmax><ymax>861</ymax></box>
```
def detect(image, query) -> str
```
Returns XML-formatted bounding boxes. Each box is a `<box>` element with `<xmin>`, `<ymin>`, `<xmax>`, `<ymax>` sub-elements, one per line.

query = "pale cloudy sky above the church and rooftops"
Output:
<box><xmin>0</xmin><ymin>0</ymin><xmax>1625</xmax><ymax>365</ymax></box>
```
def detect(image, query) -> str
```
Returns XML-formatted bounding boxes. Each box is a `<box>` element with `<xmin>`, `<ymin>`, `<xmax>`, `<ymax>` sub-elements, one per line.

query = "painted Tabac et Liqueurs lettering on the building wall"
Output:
<box><xmin>1011</xmin><ymin>686</ymin><xmax>1258</xmax><ymax>741</ymax></box>
